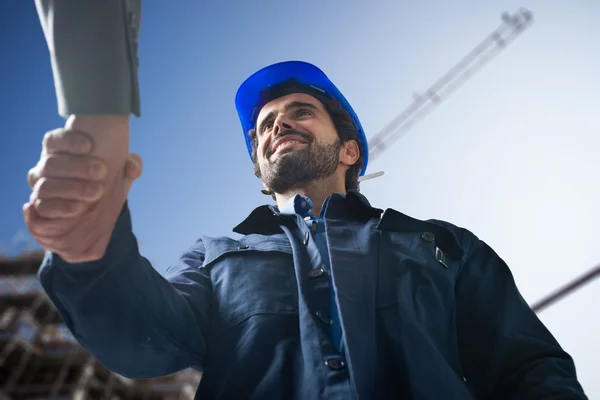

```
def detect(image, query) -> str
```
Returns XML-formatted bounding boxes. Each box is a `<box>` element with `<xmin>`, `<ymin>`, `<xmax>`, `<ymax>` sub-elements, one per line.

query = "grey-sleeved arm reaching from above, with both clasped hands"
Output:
<box><xmin>28</xmin><ymin>0</ymin><xmax>141</xmax><ymax>262</ymax></box>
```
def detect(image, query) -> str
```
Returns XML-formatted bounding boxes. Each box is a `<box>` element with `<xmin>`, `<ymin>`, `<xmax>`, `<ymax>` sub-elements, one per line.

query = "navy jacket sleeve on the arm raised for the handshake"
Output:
<box><xmin>38</xmin><ymin>205</ymin><xmax>213</xmax><ymax>378</ymax></box>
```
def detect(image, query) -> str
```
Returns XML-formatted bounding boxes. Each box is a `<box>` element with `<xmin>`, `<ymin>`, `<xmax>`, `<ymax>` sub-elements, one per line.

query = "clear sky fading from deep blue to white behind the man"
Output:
<box><xmin>0</xmin><ymin>0</ymin><xmax>600</xmax><ymax>398</ymax></box>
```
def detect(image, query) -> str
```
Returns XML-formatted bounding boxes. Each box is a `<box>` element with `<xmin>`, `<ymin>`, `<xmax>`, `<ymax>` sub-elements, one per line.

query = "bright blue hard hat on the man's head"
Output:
<box><xmin>235</xmin><ymin>61</ymin><xmax>369</xmax><ymax>176</ymax></box>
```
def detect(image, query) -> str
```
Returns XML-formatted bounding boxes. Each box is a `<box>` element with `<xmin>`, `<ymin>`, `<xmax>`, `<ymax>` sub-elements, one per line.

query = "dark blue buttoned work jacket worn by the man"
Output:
<box><xmin>39</xmin><ymin>191</ymin><xmax>586</xmax><ymax>400</ymax></box>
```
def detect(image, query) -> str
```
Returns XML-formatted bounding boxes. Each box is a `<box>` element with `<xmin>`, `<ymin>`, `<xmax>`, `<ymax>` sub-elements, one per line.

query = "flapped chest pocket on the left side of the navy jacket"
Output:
<box><xmin>201</xmin><ymin>235</ymin><xmax>298</xmax><ymax>329</ymax></box>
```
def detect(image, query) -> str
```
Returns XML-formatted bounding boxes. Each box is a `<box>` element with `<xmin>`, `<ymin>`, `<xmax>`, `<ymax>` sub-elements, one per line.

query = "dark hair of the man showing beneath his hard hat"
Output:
<box><xmin>248</xmin><ymin>87</ymin><xmax>364</xmax><ymax>199</ymax></box>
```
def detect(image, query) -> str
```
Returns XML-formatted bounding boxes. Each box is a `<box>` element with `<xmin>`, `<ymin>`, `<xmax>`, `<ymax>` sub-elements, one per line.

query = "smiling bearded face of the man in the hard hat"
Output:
<box><xmin>256</xmin><ymin>93</ymin><xmax>342</xmax><ymax>193</ymax></box>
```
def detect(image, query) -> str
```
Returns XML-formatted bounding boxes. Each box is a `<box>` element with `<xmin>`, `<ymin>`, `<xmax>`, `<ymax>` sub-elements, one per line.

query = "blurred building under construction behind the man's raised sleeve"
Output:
<box><xmin>0</xmin><ymin>252</ymin><xmax>200</xmax><ymax>400</ymax></box>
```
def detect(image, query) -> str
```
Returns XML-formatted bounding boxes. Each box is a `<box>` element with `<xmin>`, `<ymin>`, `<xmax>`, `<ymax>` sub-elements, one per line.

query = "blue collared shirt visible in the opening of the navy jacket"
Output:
<box><xmin>280</xmin><ymin>194</ymin><xmax>344</xmax><ymax>357</ymax></box>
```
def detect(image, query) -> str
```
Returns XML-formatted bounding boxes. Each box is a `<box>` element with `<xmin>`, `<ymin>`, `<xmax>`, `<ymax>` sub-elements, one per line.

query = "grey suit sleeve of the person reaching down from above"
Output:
<box><xmin>35</xmin><ymin>0</ymin><xmax>142</xmax><ymax>117</ymax></box>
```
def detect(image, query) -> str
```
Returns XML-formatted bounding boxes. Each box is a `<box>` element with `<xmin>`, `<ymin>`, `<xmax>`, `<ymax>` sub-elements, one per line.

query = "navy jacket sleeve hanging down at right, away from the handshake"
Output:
<box><xmin>456</xmin><ymin>241</ymin><xmax>587</xmax><ymax>400</ymax></box>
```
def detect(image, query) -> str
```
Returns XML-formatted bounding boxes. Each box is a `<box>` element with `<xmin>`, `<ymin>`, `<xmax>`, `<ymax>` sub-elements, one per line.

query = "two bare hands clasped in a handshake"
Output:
<box><xmin>23</xmin><ymin>116</ymin><xmax>142</xmax><ymax>263</ymax></box>
